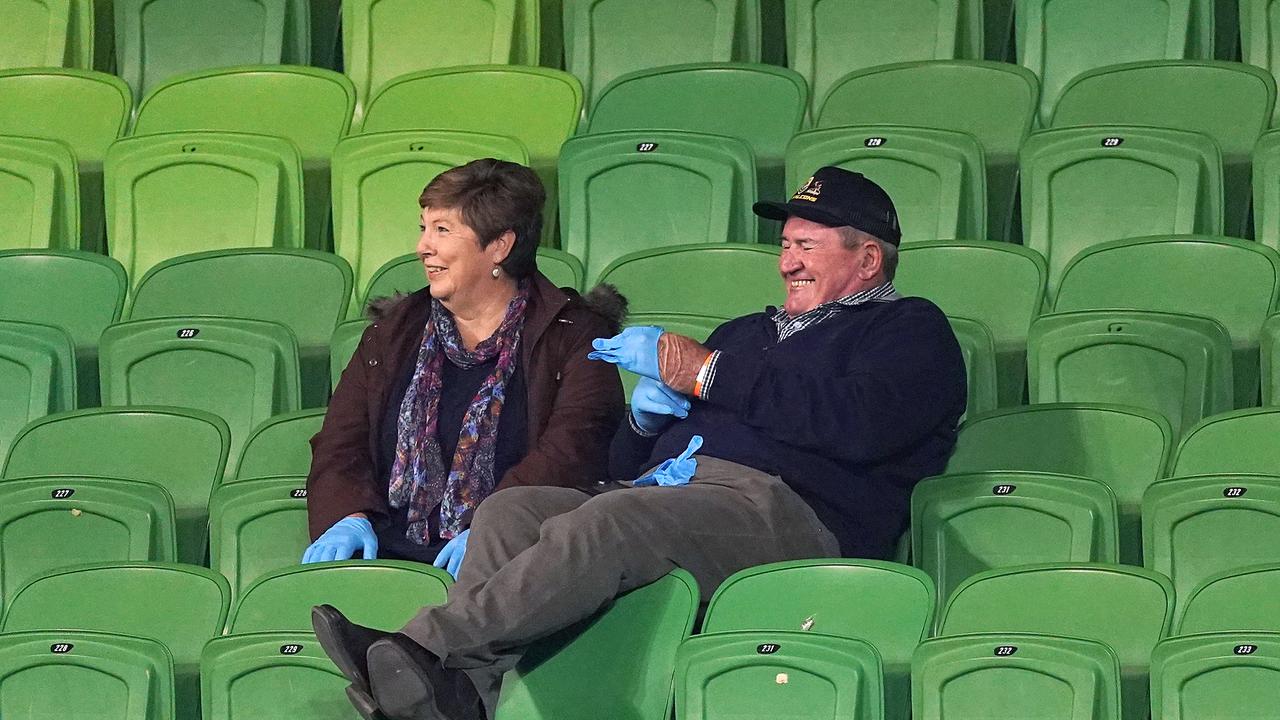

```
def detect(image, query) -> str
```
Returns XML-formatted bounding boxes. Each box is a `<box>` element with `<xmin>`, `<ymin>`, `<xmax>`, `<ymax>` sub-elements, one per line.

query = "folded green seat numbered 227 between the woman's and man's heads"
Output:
<box><xmin>559</xmin><ymin>131</ymin><xmax>756</xmax><ymax>278</ymax></box>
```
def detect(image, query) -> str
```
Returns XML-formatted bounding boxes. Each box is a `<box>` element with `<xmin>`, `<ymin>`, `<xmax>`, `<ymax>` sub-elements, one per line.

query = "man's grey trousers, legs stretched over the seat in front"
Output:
<box><xmin>402</xmin><ymin>456</ymin><xmax>840</xmax><ymax>717</ymax></box>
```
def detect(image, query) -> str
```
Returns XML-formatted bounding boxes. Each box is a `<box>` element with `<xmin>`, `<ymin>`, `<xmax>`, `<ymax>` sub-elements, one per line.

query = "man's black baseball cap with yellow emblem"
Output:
<box><xmin>751</xmin><ymin>165</ymin><xmax>902</xmax><ymax>245</ymax></box>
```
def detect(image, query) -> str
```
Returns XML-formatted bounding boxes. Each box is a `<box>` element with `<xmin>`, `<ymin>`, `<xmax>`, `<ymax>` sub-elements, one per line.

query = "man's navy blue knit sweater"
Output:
<box><xmin>609</xmin><ymin>297</ymin><xmax>968</xmax><ymax>557</ymax></box>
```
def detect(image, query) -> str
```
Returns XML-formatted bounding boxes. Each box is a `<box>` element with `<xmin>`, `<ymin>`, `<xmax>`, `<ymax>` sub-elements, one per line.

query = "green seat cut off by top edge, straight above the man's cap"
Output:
<box><xmin>786</xmin><ymin>0</ymin><xmax>964</xmax><ymax>114</ymax></box>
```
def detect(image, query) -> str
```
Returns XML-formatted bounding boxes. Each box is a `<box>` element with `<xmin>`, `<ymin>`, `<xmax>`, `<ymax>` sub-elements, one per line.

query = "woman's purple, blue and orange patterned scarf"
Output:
<box><xmin>387</xmin><ymin>281</ymin><xmax>529</xmax><ymax>544</ymax></box>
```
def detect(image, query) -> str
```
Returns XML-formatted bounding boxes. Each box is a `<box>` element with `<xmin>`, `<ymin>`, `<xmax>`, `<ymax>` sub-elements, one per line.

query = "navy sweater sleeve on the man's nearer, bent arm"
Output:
<box><xmin>708</xmin><ymin>300</ymin><xmax>966</xmax><ymax>462</ymax></box>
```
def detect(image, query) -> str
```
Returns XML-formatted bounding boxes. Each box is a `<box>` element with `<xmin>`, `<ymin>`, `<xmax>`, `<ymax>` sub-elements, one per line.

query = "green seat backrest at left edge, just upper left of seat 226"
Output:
<box><xmin>0</xmin><ymin>250</ymin><xmax>128</xmax><ymax>407</ymax></box>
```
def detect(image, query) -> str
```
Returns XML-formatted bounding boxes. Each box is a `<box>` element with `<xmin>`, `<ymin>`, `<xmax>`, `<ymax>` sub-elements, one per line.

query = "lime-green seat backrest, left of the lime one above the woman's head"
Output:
<box><xmin>133</xmin><ymin>66</ymin><xmax>356</xmax><ymax>250</ymax></box>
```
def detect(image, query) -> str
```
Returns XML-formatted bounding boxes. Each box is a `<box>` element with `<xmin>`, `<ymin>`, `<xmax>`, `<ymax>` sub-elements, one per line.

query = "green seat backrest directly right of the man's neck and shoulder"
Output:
<box><xmin>893</xmin><ymin>241</ymin><xmax>1048</xmax><ymax>406</ymax></box>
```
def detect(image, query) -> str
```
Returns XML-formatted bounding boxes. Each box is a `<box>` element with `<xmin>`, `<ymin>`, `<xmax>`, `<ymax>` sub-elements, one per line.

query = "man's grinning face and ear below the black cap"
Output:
<box><xmin>778</xmin><ymin>217</ymin><xmax>879</xmax><ymax>318</ymax></box>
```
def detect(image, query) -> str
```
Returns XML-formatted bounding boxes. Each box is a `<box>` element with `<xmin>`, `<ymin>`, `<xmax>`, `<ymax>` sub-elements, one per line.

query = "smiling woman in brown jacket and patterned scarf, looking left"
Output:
<box><xmin>302</xmin><ymin>159</ymin><xmax>626</xmax><ymax>577</ymax></box>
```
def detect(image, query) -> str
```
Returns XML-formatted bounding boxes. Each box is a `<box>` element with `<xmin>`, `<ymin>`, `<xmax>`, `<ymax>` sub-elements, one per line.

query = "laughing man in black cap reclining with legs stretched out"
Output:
<box><xmin>312</xmin><ymin>168</ymin><xmax>966</xmax><ymax>720</ymax></box>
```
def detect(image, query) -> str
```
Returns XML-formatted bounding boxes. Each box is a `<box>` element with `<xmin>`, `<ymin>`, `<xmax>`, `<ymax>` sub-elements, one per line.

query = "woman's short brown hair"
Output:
<box><xmin>417</xmin><ymin>158</ymin><xmax>547</xmax><ymax>279</ymax></box>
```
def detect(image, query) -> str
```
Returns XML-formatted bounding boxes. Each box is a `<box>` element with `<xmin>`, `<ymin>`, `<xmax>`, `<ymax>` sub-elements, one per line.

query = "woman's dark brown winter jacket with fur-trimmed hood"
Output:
<box><xmin>307</xmin><ymin>273</ymin><xmax>626</xmax><ymax>539</ymax></box>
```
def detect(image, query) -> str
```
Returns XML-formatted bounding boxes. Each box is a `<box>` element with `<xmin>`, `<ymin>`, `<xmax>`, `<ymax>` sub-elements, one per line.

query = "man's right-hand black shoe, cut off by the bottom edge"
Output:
<box><xmin>368</xmin><ymin>633</ymin><xmax>481</xmax><ymax>720</ymax></box>
